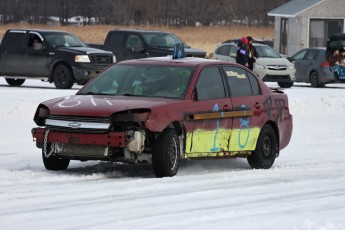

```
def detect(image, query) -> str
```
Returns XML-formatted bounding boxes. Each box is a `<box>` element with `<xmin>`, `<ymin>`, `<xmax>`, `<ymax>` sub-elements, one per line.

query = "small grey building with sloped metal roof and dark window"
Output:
<box><xmin>268</xmin><ymin>0</ymin><xmax>345</xmax><ymax>56</ymax></box>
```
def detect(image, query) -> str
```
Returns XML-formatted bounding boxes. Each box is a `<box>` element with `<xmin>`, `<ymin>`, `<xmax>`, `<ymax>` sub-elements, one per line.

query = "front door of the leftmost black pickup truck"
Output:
<box><xmin>22</xmin><ymin>31</ymin><xmax>49</xmax><ymax>77</ymax></box>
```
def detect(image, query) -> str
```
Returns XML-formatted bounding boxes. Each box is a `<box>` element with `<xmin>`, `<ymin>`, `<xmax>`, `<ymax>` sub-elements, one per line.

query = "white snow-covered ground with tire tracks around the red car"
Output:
<box><xmin>0</xmin><ymin>78</ymin><xmax>345</xmax><ymax>230</ymax></box>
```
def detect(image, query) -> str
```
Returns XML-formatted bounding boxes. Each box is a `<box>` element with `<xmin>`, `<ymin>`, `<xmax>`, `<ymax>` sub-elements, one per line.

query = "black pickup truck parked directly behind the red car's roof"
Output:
<box><xmin>89</xmin><ymin>29</ymin><xmax>206</xmax><ymax>61</ymax></box>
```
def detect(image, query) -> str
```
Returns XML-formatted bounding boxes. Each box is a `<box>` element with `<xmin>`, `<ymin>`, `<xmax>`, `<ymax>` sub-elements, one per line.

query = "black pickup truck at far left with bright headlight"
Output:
<box><xmin>0</xmin><ymin>29</ymin><xmax>116</xmax><ymax>89</ymax></box>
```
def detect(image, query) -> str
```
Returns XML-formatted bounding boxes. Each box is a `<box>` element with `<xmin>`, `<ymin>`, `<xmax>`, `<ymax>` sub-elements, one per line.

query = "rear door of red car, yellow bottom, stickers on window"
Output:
<box><xmin>223</xmin><ymin>66</ymin><xmax>264</xmax><ymax>154</ymax></box>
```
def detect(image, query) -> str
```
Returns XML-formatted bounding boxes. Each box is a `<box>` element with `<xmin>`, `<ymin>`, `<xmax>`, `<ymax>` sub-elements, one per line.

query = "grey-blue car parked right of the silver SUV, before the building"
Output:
<box><xmin>288</xmin><ymin>47</ymin><xmax>338</xmax><ymax>87</ymax></box>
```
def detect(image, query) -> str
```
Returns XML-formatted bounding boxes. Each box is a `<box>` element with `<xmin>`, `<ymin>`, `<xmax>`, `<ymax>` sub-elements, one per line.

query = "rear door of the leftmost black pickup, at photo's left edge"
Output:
<box><xmin>0</xmin><ymin>30</ymin><xmax>26</xmax><ymax>76</ymax></box>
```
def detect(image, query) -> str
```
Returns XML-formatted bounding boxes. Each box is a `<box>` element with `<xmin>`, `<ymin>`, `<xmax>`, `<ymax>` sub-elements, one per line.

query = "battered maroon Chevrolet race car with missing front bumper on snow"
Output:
<box><xmin>32</xmin><ymin>57</ymin><xmax>292</xmax><ymax>177</ymax></box>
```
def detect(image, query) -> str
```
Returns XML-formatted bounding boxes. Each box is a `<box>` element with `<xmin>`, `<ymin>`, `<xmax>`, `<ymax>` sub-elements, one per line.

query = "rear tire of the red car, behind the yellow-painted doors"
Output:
<box><xmin>247</xmin><ymin>125</ymin><xmax>279</xmax><ymax>169</ymax></box>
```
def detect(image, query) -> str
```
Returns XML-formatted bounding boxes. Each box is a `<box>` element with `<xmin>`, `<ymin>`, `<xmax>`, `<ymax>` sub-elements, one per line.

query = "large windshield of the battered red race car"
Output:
<box><xmin>78</xmin><ymin>64</ymin><xmax>194</xmax><ymax>99</ymax></box>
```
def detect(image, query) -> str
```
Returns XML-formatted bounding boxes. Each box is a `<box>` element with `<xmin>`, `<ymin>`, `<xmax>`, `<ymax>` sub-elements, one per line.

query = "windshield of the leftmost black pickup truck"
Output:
<box><xmin>45</xmin><ymin>33</ymin><xmax>86</xmax><ymax>48</ymax></box>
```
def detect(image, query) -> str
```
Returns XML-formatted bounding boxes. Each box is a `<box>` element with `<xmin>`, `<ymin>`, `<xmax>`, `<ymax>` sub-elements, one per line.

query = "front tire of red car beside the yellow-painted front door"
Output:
<box><xmin>152</xmin><ymin>129</ymin><xmax>180</xmax><ymax>177</ymax></box>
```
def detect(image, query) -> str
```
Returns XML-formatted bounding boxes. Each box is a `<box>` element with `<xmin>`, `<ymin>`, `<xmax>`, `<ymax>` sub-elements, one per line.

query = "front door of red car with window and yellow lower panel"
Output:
<box><xmin>185</xmin><ymin>66</ymin><xmax>232</xmax><ymax>157</ymax></box>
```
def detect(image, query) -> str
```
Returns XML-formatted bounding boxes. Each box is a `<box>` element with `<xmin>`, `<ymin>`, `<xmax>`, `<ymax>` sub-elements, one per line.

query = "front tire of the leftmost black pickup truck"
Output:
<box><xmin>53</xmin><ymin>64</ymin><xmax>74</xmax><ymax>89</ymax></box>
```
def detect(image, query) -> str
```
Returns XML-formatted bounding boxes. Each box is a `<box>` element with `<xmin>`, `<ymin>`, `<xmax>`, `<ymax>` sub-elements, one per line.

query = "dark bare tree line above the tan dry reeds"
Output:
<box><xmin>0</xmin><ymin>0</ymin><xmax>289</xmax><ymax>26</ymax></box>
